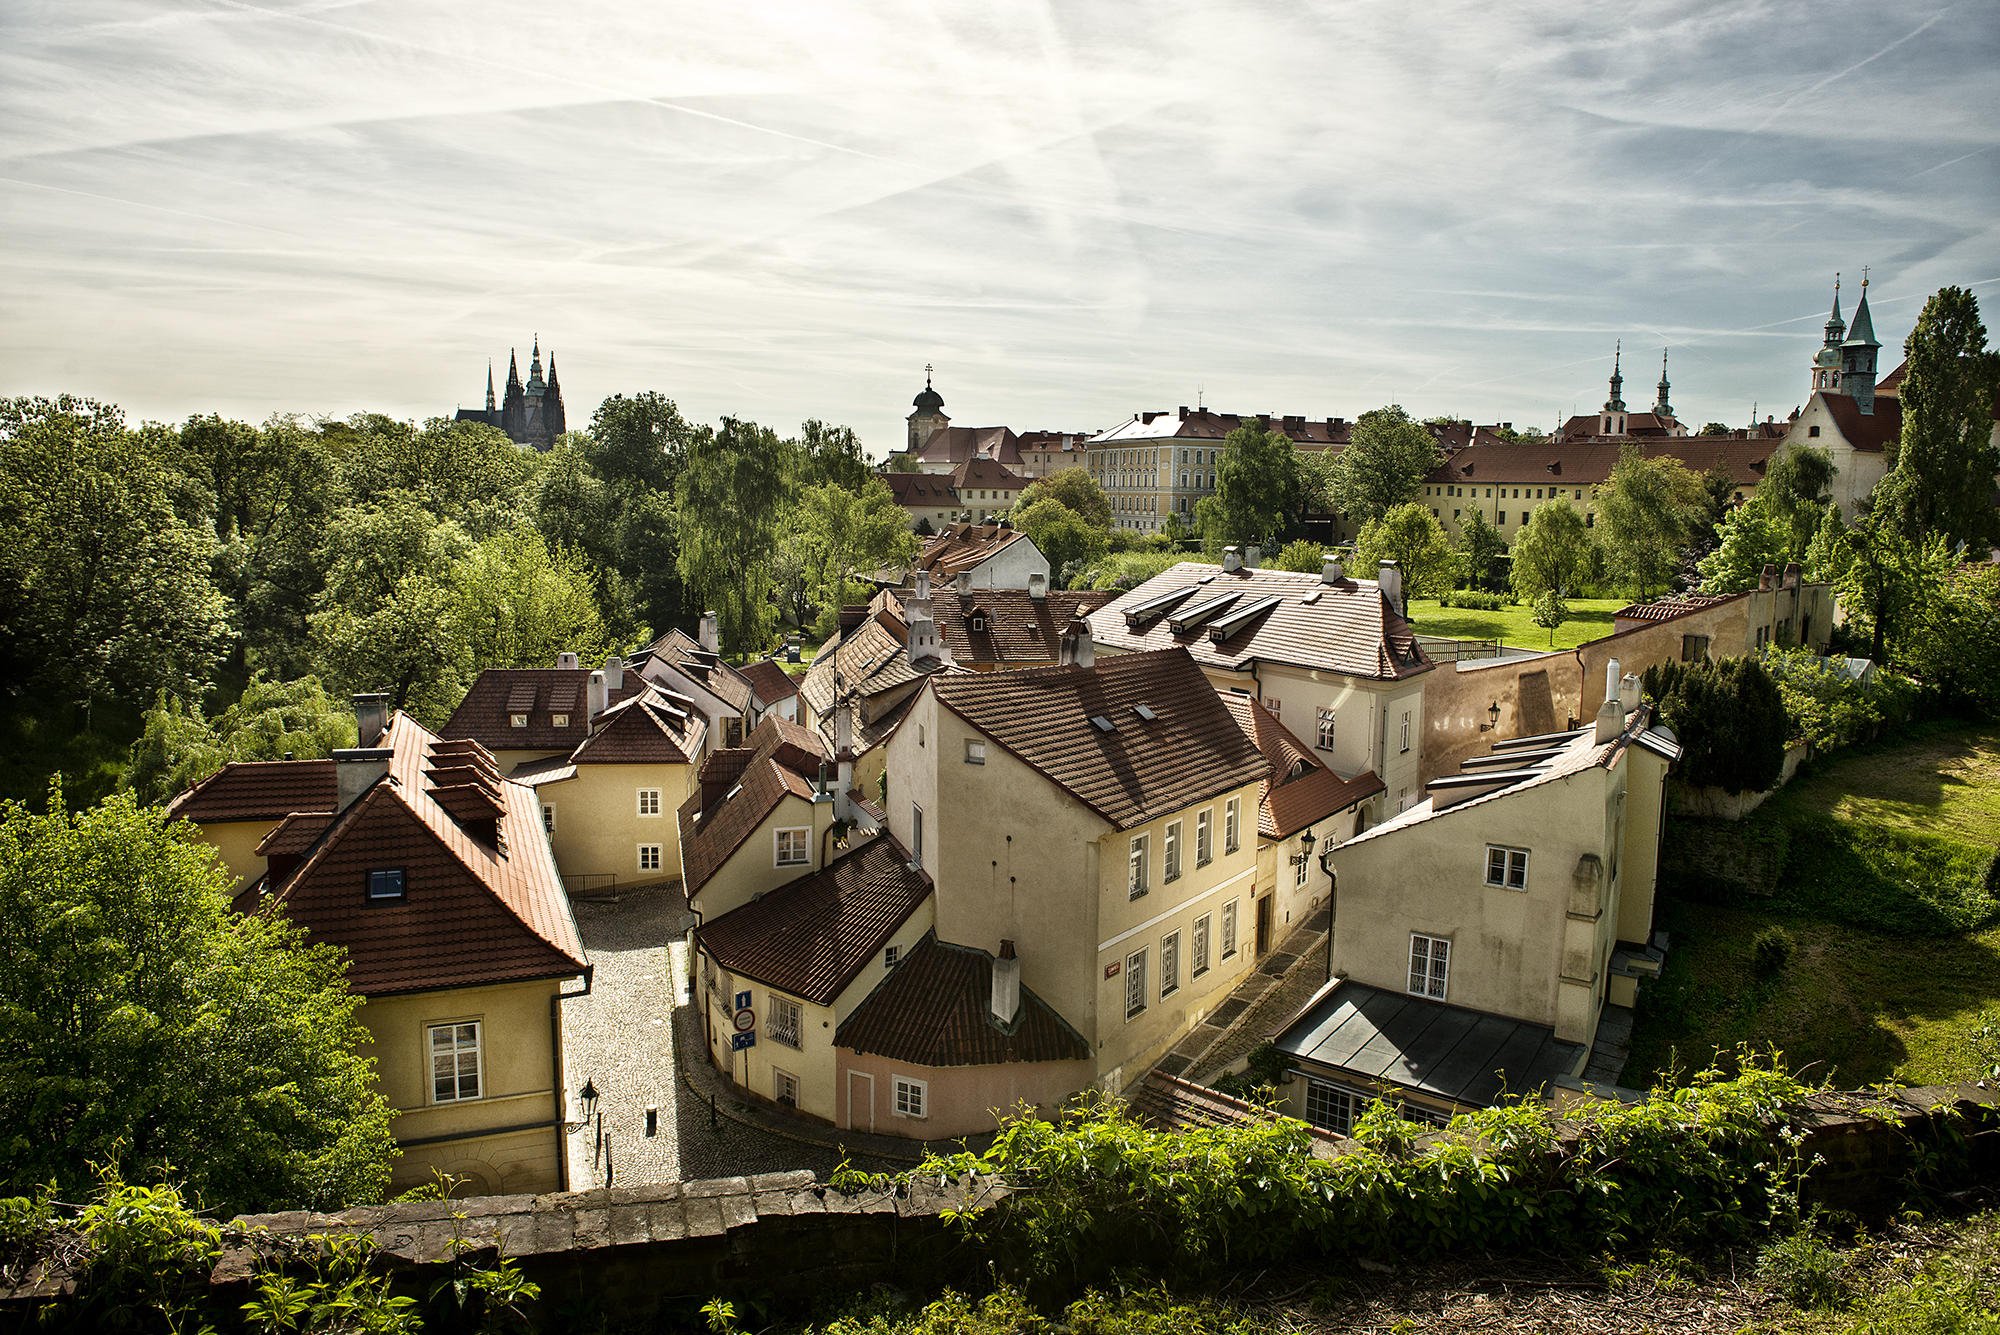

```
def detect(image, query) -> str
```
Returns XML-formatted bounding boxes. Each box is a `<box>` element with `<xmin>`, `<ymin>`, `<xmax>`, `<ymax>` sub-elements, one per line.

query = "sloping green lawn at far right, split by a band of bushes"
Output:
<box><xmin>1624</xmin><ymin>723</ymin><xmax>2000</xmax><ymax>1087</ymax></box>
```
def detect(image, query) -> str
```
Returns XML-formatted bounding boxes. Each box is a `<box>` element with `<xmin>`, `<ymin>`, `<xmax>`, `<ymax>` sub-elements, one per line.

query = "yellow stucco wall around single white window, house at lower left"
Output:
<box><xmin>358</xmin><ymin>981</ymin><xmax>564</xmax><ymax>1193</ymax></box>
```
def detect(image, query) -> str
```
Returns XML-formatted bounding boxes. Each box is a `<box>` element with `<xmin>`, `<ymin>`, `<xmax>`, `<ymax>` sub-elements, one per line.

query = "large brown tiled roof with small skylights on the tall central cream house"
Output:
<box><xmin>930</xmin><ymin>648</ymin><xmax>1270</xmax><ymax>829</ymax></box>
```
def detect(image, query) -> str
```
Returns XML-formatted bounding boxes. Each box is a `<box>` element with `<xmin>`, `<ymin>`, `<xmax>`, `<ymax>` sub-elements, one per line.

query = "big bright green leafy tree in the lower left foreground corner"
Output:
<box><xmin>0</xmin><ymin>787</ymin><xmax>394</xmax><ymax>1215</ymax></box>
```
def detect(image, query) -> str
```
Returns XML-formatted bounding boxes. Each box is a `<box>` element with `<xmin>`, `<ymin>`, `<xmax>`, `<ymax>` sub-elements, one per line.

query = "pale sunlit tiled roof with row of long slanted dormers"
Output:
<box><xmin>1090</xmin><ymin>562</ymin><xmax>1432</xmax><ymax>681</ymax></box>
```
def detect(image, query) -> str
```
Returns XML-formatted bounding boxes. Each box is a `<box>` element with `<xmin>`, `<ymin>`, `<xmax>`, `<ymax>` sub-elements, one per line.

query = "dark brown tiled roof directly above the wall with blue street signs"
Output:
<box><xmin>694</xmin><ymin>833</ymin><xmax>932</xmax><ymax>1005</ymax></box>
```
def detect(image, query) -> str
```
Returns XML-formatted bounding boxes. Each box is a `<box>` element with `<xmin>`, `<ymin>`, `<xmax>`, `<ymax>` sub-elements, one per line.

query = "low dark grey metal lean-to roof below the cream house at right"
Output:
<box><xmin>1276</xmin><ymin>981</ymin><xmax>1584</xmax><ymax>1105</ymax></box>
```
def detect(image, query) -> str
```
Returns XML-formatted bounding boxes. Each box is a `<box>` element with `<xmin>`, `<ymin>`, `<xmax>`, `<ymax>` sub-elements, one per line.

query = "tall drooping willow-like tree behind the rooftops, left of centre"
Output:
<box><xmin>678</xmin><ymin>418</ymin><xmax>792</xmax><ymax>654</ymax></box>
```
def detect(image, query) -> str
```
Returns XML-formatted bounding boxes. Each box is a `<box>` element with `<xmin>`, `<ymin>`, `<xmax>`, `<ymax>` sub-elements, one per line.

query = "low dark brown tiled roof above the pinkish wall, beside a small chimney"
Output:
<box><xmin>834</xmin><ymin>931</ymin><xmax>1090</xmax><ymax>1065</ymax></box>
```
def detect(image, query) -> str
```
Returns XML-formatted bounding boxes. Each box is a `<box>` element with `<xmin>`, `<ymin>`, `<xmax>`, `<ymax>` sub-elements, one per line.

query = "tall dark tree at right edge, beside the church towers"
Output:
<box><xmin>1876</xmin><ymin>288</ymin><xmax>2000</xmax><ymax>548</ymax></box>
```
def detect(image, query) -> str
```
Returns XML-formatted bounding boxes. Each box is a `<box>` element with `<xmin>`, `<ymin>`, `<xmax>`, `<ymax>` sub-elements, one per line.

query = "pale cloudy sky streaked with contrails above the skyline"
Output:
<box><xmin>0</xmin><ymin>0</ymin><xmax>2000</xmax><ymax>456</ymax></box>
